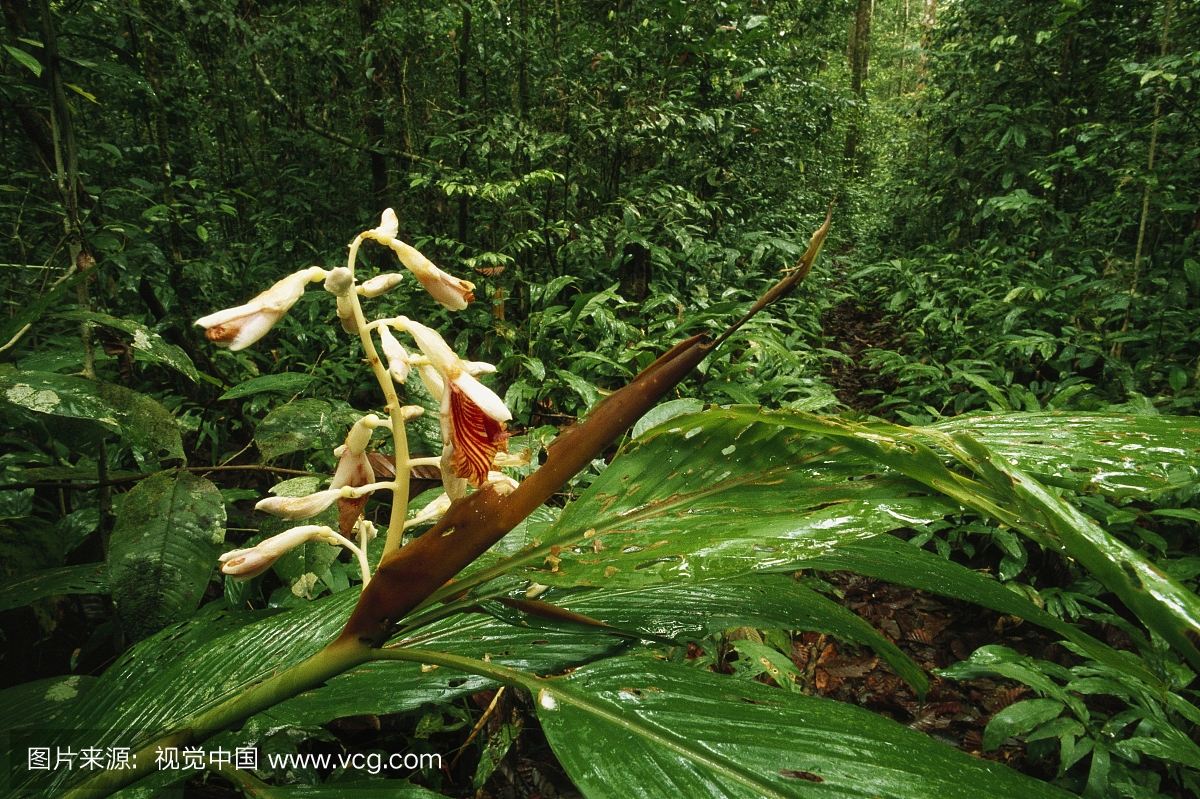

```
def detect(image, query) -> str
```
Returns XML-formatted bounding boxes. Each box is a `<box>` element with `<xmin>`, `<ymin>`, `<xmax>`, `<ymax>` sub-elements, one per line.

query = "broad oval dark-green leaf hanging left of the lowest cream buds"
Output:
<box><xmin>108</xmin><ymin>471</ymin><xmax>226</xmax><ymax>638</ymax></box>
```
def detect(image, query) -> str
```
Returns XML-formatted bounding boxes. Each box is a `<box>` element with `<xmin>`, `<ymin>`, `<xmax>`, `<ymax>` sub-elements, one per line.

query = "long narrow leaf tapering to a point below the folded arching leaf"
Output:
<box><xmin>794</xmin><ymin>535</ymin><xmax>1160</xmax><ymax>685</ymax></box>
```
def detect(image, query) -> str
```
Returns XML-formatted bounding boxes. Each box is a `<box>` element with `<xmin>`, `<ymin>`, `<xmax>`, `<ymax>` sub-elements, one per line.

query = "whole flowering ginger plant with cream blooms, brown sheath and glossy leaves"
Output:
<box><xmin>14</xmin><ymin>206</ymin><xmax>1200</xmax><ymax>798</ymax></box>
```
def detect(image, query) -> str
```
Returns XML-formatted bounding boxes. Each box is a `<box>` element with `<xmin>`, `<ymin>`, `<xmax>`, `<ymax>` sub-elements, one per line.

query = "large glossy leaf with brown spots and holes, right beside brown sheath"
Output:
<box><xmin>480</xmin><ymin>411</ymin><xmax>958</xmax><ymax>588</ymax></box>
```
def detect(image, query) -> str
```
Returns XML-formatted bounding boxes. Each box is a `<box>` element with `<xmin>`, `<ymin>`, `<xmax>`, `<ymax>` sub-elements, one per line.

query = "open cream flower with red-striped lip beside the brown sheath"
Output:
<box><xmin>394</xmin><ymin>317</ymin><xmax>512</xmax><ymax>484</ymax></box>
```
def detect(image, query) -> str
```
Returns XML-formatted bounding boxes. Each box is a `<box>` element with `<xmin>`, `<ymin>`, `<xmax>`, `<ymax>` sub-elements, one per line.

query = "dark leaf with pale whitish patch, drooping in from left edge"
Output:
<box><xmin>0</xmin><ymin>372</ymin><xmax>184</xmax><ymax>458</ymax></box>
